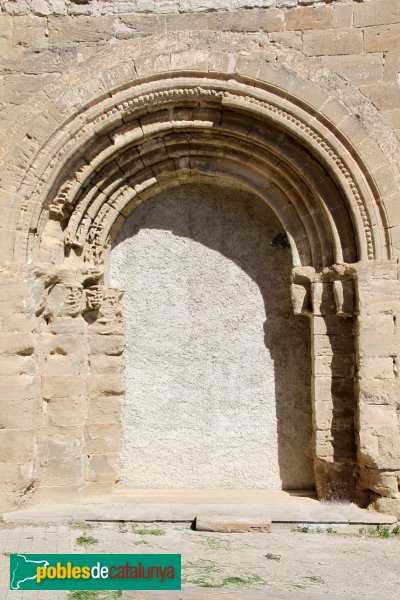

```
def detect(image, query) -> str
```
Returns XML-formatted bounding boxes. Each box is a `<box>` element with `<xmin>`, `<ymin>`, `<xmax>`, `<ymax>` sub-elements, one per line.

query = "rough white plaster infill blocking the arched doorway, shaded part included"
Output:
<box><xmin>110</xmin><ymin>184</ymin><xmax>313</xmax><ymax>489</ymax></box>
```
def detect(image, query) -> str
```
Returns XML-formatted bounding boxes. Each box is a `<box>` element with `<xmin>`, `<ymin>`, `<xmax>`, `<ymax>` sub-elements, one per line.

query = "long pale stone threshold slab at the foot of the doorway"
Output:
<box><xmin>3</xmin><ymin>500</ymin><xmax>396</xmax><ymax>525</ymax></box>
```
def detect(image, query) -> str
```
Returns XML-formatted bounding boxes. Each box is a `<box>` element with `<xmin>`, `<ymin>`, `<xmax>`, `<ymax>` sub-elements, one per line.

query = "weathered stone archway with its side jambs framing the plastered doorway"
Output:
<box><xmin>2</xmin><ymin>36</ymin><xmax>399</xmax><ymax>508</ymax></box>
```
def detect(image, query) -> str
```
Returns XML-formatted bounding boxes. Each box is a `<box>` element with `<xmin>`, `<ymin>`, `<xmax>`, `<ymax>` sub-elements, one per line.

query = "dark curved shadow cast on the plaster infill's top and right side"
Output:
<box><xmin>111</xmin><ymin>184</ymin><xmax>314</xmax><ymax>489</ymax></box>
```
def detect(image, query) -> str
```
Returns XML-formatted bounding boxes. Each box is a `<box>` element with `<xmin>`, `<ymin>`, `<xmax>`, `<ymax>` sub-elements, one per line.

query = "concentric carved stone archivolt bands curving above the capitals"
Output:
<box><xmin>10</xmin><ymin>72</ymin><xmax>392</xmax><ymax>268</ymax></box>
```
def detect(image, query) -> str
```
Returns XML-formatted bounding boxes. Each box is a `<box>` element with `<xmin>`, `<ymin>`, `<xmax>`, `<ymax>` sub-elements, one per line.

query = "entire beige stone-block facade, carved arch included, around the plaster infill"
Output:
<box><xmin>0</xmin><ymin>0</ymin><xmax>400</xmax><ymax>506</ymax></box>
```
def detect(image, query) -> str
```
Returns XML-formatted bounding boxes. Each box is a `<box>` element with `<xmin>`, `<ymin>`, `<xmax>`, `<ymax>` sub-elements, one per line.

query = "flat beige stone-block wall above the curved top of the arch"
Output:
<box><xmin>0</xmin><ymin>0</ymin><xmax>400</xmax><ymax>135</ymax></box>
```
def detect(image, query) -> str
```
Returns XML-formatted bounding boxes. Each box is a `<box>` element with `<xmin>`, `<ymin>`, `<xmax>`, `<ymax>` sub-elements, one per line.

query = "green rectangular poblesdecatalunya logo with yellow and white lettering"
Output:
<box><xmin>10</xmin><ymin>554</ymin><xmax>182</xmax><ymax>590</ymax></box>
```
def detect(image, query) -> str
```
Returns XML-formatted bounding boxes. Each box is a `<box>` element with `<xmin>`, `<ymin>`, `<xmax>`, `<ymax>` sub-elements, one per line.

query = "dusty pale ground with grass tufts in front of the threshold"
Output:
<box><xmin>0</xmin><ymin>522</ymin><xmax>400</xmax><ymax>600</ymax></box>
